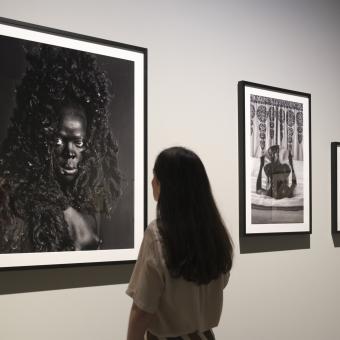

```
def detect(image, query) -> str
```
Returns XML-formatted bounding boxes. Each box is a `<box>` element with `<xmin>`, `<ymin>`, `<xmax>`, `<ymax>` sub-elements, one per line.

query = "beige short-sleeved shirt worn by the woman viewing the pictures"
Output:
<box><xmin>126</xmin><ymin>221</ymin><xmax>229</xmax><ymax>337</ymax></box>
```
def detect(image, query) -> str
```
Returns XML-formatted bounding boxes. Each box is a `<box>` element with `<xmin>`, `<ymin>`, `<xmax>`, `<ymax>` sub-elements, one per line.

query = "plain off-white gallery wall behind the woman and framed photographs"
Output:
<box><xmin>0</xmin><ymin>0</ymin><xmax>340</xmax><ymax>340</ymax></box>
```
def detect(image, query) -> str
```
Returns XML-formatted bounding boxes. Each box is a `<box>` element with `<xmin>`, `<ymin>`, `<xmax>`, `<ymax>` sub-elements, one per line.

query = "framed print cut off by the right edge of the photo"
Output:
<box><xmin>331</xmin><ymin>142</ymin><xmax>340</xmax><ymax>233</ymax></box>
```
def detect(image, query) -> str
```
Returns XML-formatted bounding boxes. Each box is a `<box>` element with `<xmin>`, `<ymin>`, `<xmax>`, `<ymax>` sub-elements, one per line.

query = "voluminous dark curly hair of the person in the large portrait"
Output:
<box><xmin>0</xmin><ymin>44</ymin><xmax>122</xmax><ymax>251</ymax></box>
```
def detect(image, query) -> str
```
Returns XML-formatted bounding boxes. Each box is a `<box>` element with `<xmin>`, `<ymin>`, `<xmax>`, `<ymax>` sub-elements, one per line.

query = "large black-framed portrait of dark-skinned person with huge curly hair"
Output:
<box><xmin>0</xmin><ymin>18</ymin><xmax>147</xmax><ymax>268</ymax></box>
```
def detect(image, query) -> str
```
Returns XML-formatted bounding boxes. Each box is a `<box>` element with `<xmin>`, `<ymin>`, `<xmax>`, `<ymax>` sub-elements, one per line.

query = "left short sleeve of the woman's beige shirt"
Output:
<box><xmin>126</xmin><ymin>228</ymin><xmax>164</xmax><ymax>314</ymax></box>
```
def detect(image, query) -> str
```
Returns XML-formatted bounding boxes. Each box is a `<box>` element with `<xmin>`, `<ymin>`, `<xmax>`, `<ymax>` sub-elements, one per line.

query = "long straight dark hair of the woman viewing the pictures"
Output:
<box><xmin>154</xmin><ymin>147</ymin><xmax>233</xmax><ymax>284</ymax></box>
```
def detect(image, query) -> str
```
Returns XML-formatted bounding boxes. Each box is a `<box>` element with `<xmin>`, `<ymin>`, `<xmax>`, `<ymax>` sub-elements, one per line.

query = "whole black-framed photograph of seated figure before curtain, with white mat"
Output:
<box><xmin>238</xmin><ymin>81</ymin><xmax>311</xmax><ymax>235</ymax></box>
